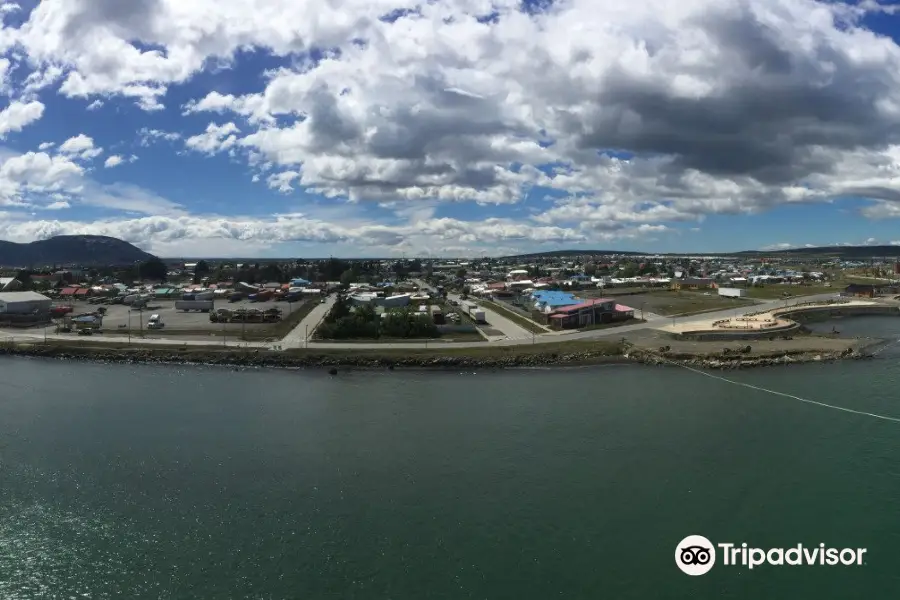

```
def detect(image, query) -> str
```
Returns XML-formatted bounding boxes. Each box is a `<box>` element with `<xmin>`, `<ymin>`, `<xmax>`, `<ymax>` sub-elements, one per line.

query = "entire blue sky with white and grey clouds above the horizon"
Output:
<box><xmin>0</xmin><ymin>0</ymin><xmax>900</xmax><ymax>258</ymax></box>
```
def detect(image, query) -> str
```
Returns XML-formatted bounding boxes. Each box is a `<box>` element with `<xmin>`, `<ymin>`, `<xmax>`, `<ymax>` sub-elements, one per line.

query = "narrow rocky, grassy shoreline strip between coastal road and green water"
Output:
<box><xmin>0</xmin><ymin>338</ymin><xmax>889</xmax><ymax>370</ymax></box>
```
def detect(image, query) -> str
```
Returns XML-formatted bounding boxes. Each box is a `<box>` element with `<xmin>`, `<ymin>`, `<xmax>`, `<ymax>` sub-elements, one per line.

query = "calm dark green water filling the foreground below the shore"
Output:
<box><xmin>0</xmin><ymin>317</ymin><xmax>900</xmax><ymax>600</ymax></box>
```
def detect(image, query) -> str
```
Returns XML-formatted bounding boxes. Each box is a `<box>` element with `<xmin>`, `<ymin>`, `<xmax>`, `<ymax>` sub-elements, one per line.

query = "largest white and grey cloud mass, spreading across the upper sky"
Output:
<box><xmin>0</xmin><ymin>0</ymin><xmax>900</xmax><ymax>247</ymax></box>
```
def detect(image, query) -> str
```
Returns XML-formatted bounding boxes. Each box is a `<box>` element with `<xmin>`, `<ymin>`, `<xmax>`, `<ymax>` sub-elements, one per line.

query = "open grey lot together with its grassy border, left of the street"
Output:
<box><xmin>46</xmin><ymin>299</ymin><xmax>316</xmax><ymax>341</ymax></box>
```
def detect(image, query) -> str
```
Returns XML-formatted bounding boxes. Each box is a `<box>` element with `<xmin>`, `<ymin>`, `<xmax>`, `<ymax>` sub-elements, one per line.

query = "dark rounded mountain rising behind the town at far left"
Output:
<box><xmin>0</xmin><ymin>235</ymin><xmax>155</xmax><ymax>267</ymax></box>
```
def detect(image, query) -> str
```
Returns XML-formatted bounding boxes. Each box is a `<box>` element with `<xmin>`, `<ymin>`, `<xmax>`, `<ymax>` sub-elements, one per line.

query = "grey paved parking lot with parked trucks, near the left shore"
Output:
<box><xmin>46</xmin><ymin>299</ymin><xmax>310</xmax><ymax>337</ymax></box>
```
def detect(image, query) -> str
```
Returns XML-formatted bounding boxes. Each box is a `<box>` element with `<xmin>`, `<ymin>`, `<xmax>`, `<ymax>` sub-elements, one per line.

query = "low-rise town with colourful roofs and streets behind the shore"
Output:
<box><xmin>0</xmin><ymin>254</ymin><xmax>900</xmax><ymax>347</ymax></box>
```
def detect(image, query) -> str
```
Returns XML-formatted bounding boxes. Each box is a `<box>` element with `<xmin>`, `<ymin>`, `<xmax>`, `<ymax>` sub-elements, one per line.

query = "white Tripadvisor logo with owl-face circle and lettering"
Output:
<box><xmin>675</xmin><ymin>535</ymin><xmax>866</xmax><ymax>575</ymax></box>
